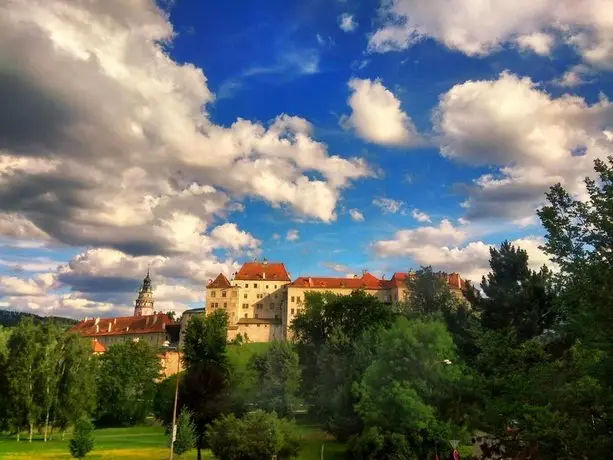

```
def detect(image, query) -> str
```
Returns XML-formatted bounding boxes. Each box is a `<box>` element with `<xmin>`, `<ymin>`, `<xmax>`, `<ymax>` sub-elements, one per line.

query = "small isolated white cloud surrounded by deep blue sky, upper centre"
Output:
<box><xmin>341</xmin><ymin>78</ymin><xmax>422</xmax><ymax>146</ymax></box>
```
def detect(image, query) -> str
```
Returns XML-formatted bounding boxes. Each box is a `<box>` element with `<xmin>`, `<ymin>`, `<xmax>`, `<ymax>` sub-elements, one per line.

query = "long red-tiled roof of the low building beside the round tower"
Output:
<box><xmin>69</xmin><ymin>313</ymin><xmax>172</xmax><ymax>337</ymax></box>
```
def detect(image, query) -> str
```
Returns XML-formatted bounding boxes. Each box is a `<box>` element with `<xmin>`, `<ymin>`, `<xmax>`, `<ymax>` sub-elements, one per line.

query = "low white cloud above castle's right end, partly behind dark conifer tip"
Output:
<box><xmin>372</xmin><ymin>220</ymin><xmax>553</xmax><ymax>283</ymax></box>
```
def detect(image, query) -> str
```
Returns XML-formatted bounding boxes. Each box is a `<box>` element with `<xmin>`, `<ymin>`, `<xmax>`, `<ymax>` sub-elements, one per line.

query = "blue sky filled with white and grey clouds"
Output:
<box><xmin>0</xmin><ymin>0</ymin><xmax>613</xmax><ymax>318</ymax></box>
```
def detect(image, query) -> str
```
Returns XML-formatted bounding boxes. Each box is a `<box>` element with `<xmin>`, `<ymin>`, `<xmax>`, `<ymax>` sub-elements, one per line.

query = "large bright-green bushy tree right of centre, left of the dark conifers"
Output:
<box><xmin>355</xmin><ymin>317</ymin><xmax>464</xmax><ymax>458</ymax></box>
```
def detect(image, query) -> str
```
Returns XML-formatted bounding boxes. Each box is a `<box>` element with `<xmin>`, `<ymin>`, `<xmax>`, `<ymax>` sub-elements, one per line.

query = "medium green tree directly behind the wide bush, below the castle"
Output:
<box><xmin>249</xmin><ymin>342</ymin><xmax>300</xmax><ymax>417</ymax></box>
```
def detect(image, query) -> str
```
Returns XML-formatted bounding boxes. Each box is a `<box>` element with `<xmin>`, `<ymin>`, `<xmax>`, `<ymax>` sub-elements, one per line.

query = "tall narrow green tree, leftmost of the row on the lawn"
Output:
<box><xmin>6</xmin><ymin>318</ymin><xmax>40</xmax><ymax>442</ymax></box>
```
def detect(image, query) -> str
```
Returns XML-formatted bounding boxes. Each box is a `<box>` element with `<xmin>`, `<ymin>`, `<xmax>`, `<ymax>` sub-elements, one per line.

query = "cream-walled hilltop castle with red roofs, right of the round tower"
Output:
<box><xmin>203</xmin><ymin>260</ymin><xmax>465</xmax><ymax>342</ymax></box>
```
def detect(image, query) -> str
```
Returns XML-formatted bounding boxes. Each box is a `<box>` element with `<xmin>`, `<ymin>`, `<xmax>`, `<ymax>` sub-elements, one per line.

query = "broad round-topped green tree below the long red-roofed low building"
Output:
<box><xmin>96</xmin><ymin>340</ymin><xmax>161</xmax><ymax>425</ymax></box>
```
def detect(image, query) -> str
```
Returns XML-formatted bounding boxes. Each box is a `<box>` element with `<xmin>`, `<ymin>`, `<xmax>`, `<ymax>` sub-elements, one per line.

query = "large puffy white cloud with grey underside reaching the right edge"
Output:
<box><xmin>434</xmin><ymin>72</ymin><xmax>613</xmax><ymax>220</ymax></box>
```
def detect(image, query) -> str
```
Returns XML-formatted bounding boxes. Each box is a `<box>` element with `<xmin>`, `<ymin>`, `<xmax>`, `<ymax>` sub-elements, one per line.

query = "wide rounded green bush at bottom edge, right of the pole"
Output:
<box><xmin>207</xmin><ymin>410</ymin><xmax>300</xmax><ymax>460</ymax></box>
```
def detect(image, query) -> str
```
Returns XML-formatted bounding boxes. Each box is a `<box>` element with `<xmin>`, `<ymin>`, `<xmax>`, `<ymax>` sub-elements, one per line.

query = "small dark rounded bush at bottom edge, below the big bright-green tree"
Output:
<box><xmin>347</xmin><ymin>428</ymin><xmax>417</xmax><ymax>460</ymax></box>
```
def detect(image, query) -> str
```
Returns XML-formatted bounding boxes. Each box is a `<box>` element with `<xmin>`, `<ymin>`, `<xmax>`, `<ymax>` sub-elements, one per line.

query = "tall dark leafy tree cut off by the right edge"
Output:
<box><xmin>538</xmin><ymin>156</ymin><xmax>613</xmax><ymax>458</ymax></box>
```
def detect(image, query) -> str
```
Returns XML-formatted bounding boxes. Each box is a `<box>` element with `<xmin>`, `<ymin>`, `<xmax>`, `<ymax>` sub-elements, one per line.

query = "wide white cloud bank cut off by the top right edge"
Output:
<box><xmin>368</xmin><ymin>0</ymin><xmax>613</xmax><ymax>68</ymax></box>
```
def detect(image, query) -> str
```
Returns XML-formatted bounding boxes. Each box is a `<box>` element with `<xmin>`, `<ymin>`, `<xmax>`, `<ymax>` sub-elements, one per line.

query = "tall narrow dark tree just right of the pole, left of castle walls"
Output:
<box><xmin>181</xmin><ymin>310</ymin><xmax>230</xmax><ymax>460</ymax></box>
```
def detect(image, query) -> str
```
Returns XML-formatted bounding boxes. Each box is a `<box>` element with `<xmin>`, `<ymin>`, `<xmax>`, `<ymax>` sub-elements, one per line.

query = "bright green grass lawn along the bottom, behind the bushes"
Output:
<box><xmin>0</xmin><ymin>424</ymin><xmax>344</xmax><ymax>460</ymax></box>
